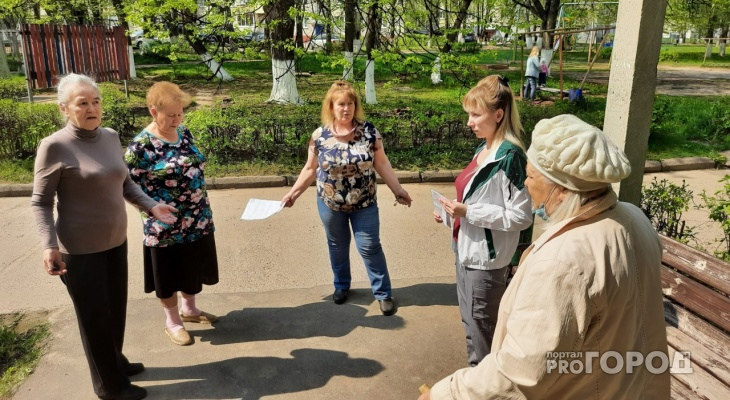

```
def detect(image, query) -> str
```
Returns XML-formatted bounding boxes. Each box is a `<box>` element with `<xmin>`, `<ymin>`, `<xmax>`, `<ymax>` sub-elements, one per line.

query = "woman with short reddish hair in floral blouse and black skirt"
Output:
<box><xmin>125</xmin><ymin>82</ymin><xmax>218</xmax><ymax>346</ymax></box>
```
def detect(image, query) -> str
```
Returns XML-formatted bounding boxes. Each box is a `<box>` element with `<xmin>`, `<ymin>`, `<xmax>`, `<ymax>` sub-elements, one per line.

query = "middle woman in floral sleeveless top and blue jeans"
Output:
<box><xmin>281</xmin><ymin>81</ymin><xmax>411</xmax><ymax>315</ymax></box>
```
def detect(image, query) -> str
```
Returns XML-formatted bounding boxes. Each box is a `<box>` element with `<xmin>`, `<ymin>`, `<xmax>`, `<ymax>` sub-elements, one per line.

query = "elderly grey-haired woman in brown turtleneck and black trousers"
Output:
<box><xmin>31</xmin><ymin>74</ymin><xmax>177</xmax><ymax>400</ymax></box>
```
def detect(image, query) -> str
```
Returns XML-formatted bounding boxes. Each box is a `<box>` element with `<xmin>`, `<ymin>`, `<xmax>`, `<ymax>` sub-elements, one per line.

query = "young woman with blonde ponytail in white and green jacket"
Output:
<box><xmin>434</xmin><ymin>75</ymin><xmax>532</xmax><ymax>366</ymax></box>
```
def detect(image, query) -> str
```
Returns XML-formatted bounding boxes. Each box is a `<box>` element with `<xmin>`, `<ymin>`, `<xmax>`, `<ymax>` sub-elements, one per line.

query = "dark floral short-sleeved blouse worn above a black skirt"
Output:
<box><xmin>124</xmin><ymin>126</ymin><xmax>215</xmax><ymax>247</ymax></box>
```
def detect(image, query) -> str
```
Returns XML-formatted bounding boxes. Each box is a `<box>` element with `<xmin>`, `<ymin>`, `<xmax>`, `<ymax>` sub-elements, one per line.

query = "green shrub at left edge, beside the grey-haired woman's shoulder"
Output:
<box><xmin>0</xmin><ymin>100</ymin><xmax>63</xmax><ymax>160</ymax></box>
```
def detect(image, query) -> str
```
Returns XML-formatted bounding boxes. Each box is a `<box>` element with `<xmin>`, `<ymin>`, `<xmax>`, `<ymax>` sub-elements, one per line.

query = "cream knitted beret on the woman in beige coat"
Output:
<box><xmin>527</xmin><ymin>114</ymin><xmax>631</xmax><ymax>192</ymax></box>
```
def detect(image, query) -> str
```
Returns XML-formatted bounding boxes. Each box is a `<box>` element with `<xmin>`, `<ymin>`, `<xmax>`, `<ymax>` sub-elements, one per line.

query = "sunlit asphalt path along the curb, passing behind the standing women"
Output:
<box><xmin>0</xmin><ymin>184</ymin><xmax>455</xmax><ymax>314</ymax></box>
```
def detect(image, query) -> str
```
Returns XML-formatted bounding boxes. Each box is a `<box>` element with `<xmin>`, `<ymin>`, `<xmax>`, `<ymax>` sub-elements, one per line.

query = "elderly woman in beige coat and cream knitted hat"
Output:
<box><xmin>421</xmin><ymin>115</ymin><xmax>671</xmax><ymax>399</ymax></box>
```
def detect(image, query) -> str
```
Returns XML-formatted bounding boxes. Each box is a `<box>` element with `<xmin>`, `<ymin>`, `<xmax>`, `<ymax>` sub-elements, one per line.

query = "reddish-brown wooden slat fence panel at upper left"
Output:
<box><xmin>20</xmin><ymin>24</ymin><xmax>130</xmax><ymax>89</ymax></box>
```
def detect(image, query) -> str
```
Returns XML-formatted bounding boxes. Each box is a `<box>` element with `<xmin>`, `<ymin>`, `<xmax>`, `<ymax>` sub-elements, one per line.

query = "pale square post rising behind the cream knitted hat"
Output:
<box><xmin>603</xmin><ymin>0</ymin><xmax>667</xmax><ymax>205</ymax></box>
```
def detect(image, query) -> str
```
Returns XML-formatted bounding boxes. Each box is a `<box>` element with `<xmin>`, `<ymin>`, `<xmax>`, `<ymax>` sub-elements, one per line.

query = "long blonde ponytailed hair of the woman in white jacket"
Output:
<box><xmin>461</xmin><ymin>75</ymin><xmax>525</xmax><ymax>151</ymax></box>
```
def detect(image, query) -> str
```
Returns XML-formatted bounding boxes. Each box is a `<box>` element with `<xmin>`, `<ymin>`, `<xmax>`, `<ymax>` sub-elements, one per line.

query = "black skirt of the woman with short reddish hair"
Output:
<box><xmin>143</xmin><ymin>233</ymin><xmax>218</xmax><ymax>299</ymax></box>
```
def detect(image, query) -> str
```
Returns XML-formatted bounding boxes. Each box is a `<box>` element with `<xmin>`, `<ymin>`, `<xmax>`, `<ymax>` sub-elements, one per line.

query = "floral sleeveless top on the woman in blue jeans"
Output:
<box><xmin>312</xmin><ymin>122</ymin><xmax>380</xmax><ymax>212</ymax></box>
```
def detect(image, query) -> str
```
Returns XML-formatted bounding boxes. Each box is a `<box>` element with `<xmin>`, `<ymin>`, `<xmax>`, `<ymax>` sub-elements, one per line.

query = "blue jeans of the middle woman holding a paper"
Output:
<box><xmin>317</xmin><ymin>197</ymin><xmax>391</xmax><ymax>300</ymax></box>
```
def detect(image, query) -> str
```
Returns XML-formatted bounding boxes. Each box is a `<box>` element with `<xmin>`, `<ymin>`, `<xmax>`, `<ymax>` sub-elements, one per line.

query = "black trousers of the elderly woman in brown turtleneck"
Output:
<box><xmin>61</xmin><ymin>242</ymin><xmax>130</xmax><ymax>396</ymax></box>
